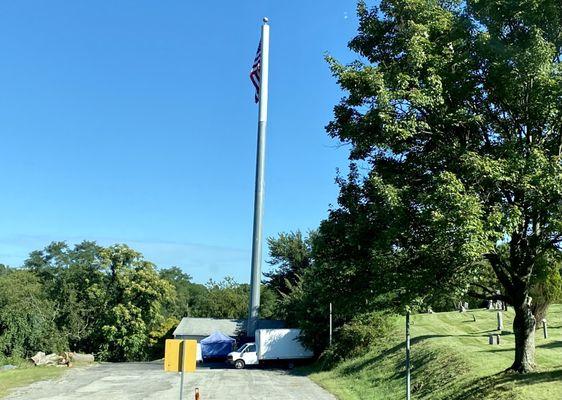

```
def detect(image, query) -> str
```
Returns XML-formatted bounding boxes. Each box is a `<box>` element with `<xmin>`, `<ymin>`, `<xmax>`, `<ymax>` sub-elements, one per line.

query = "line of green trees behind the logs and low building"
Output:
<box><xmin>0</xmin><ymin>241</ymin><xmax>275</xmax><ymax>361</ymax></box>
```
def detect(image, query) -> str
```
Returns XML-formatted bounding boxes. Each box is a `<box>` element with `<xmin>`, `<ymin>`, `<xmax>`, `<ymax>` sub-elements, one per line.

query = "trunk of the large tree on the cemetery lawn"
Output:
<box><xmin>509</xmin><ymin>303</ymin><xmax>536</xmax><ymax>373</ymax></box>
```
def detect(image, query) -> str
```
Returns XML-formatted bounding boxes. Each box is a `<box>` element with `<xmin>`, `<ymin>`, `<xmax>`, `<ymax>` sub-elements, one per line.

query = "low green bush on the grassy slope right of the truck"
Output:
<box><xmin>321</xmin><ymin>311</ymin><xmax>396</xmax><ymax>367</ymax></box>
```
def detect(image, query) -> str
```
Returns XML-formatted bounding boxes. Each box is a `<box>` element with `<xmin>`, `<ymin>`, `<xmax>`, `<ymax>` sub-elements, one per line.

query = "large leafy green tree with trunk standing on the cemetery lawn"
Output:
<box><xmin>327</xmin><ymin>0</ymin><xmax>562</xmax><ymax>372</ymax></box>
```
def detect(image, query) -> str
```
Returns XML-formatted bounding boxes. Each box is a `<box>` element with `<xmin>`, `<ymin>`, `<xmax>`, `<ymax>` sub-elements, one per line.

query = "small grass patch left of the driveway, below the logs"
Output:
<box><xmin>0</xmin><ymin>361</ymin><xmax>68</xmax><ymax>397</ymax></box>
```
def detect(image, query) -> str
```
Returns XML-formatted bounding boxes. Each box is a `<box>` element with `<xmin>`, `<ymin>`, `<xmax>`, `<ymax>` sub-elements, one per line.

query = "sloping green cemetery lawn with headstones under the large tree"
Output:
<box><xmin>310</xmin><ymin>305</ymin><xmax>562</xmax><ymax>400</ymax></box>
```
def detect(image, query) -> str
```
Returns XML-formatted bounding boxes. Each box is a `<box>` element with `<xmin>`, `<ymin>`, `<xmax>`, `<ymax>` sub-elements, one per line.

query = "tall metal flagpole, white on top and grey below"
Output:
<box><xmin>247</xmin><ymin>18</ymin><xmax>269</xmax><ymax>336</ymax></box>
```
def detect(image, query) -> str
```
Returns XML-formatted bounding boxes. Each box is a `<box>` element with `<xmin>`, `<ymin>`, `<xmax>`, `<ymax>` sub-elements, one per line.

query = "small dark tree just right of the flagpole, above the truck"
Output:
<box><xmin>264</xmin><ymin>231</ymin><xmax>314</xmax><ymax>294</ymax></box>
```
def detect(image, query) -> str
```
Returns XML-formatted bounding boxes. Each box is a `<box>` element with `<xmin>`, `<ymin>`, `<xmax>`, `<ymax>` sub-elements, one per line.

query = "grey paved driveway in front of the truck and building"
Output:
<box><xmin>6</xmin><ymin>363</ymin><xmax>335</xmax><ymax>400</ymax></box>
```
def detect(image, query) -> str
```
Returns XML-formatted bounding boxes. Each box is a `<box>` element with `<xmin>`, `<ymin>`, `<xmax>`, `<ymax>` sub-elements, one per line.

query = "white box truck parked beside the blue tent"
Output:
<box><xmin>228</xmin><ymin>329</ymin><xmax>314</xmax><ymax>369</ymax></box>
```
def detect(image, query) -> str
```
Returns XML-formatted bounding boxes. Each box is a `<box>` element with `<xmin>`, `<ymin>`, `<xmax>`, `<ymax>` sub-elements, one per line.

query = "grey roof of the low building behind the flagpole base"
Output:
<box><xmin>173</xmin><ymin>317</ymin><xmax>285</xmax><ymax>337</ymax></box>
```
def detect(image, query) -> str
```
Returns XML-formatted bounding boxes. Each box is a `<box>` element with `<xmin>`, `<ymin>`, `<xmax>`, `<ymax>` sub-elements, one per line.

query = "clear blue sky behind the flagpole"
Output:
<box><xmin>0</xmin><ymin>0</ymin><xmax>357</xmax><ymax>282</ymax></box>
